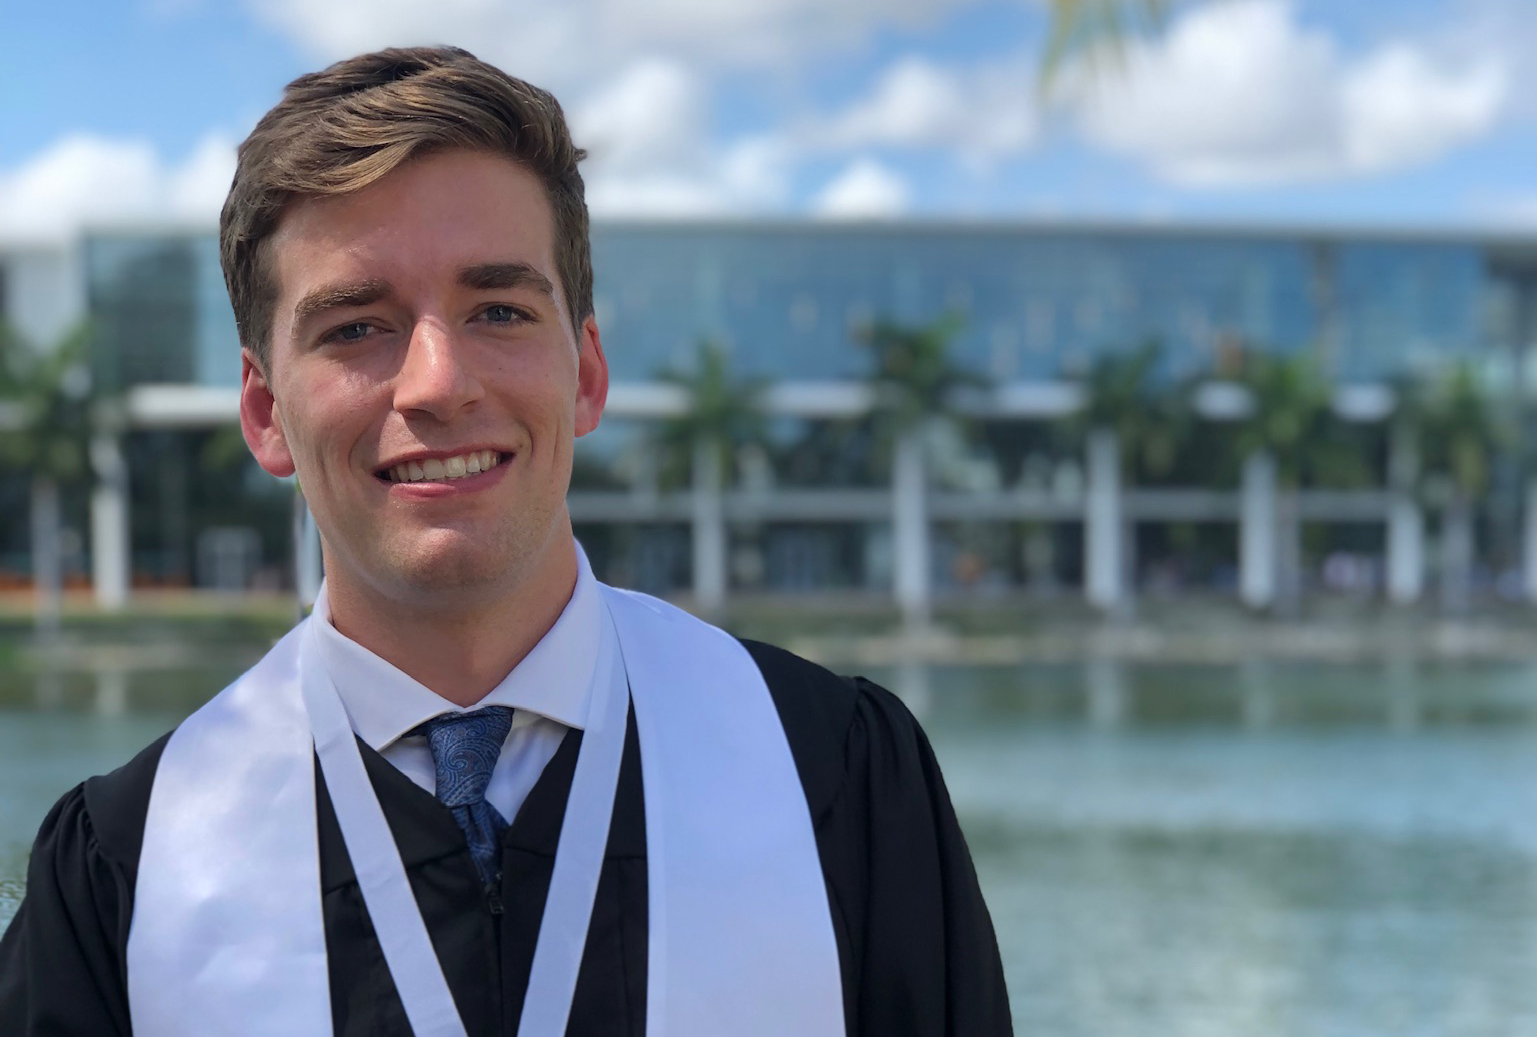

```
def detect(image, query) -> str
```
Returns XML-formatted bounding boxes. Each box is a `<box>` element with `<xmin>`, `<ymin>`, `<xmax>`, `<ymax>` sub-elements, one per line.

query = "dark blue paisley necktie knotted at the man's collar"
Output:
<box><xmin>413</xmin><ymin>705</ymin><xmax>512</xmax><ymax>886</ymax></box>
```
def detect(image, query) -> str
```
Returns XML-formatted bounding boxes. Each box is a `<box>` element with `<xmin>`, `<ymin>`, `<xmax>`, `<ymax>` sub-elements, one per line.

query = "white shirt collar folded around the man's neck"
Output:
<box><xmin>310</xmin><ymin>544</ymin><xmax>606</xmax><ymax>750</ymax></box>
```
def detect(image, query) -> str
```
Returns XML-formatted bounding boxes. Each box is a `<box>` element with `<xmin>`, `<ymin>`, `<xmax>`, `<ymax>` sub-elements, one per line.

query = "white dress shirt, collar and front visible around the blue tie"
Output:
<box><xmin>314</xmin><ymin>548</ymin><xmax>613</xmax><ymax>823</ymax></box>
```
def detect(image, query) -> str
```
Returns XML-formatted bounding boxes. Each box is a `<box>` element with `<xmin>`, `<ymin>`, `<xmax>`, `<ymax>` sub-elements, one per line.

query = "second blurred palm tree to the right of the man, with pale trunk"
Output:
<box><xmin>856</xmin><ymin>315</ymin><xmax>984</xmax><ymax>624</ymax></box>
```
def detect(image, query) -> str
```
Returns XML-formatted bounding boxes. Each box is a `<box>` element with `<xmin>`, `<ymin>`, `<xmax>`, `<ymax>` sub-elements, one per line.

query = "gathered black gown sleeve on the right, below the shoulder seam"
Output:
<box><xmin>818</xmin><ymin>678</ymin><xmax>1013</xmax><ymax>1037</ymax></box>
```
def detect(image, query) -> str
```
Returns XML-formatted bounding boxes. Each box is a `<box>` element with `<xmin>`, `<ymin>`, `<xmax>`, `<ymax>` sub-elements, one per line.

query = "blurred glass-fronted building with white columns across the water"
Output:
<box><xmin>0</xmin><ymin>220</ymin><xmax>1537</xmax><ymax>615</ymax></box>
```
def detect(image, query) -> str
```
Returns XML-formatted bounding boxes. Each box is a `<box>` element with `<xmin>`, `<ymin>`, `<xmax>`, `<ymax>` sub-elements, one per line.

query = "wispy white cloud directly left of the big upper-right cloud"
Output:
<box><xmin>805</xmin><ymin>57</ymin><xmax>1036</xmax><ymax>161</ymax></box>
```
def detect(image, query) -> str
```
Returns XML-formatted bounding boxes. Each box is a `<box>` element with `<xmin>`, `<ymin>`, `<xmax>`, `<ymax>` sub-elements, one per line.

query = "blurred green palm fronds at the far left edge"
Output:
<box><xmin>0</xmin><ymin>324</ymin><xmax>94</xmax><ymax>484</ymax></box>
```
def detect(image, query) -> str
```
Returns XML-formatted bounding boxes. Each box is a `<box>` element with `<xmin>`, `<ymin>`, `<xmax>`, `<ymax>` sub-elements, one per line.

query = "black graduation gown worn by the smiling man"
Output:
<box><xmin>0</xmin><ymin>642</ymin><xmax>1013</xmax><ymax>1037</ymax></box>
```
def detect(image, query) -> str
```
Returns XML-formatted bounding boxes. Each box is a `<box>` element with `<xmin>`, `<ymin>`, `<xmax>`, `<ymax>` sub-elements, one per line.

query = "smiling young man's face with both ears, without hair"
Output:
<box><xmin>241</xmin><ymin>151</ymin><xmax>609</xmax><ymax>604</ymax></box>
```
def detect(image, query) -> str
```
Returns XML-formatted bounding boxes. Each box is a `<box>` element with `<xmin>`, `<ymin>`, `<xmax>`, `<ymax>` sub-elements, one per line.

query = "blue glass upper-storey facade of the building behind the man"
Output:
<box><xmin>85</xmin><ymin>223</ymin><xmax>1494</xmax><ymax>387</ymax></box>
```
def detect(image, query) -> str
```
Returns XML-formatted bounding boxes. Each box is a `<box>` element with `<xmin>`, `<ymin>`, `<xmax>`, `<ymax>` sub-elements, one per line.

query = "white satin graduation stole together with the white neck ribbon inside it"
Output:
<box><xmin>128</xmin><ymin>587</ymin><xmax>844</xmax><ymax>1037</ymax></box>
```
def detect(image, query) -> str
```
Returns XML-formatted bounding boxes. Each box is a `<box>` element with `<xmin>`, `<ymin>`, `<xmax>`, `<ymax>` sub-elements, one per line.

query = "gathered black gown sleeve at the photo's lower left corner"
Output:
<box><xmin>0</xmin><ymin>785</ymin><xmax>132</xmax><ymax>1037</ymax></box>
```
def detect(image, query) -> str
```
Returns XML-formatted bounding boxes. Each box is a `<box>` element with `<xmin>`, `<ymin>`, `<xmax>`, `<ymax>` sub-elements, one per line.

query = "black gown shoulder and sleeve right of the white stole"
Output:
<box><xmin>742</xmin><ymin>641</ymin><xmax>1013</xmax><ymax>1037</ymax></box>
